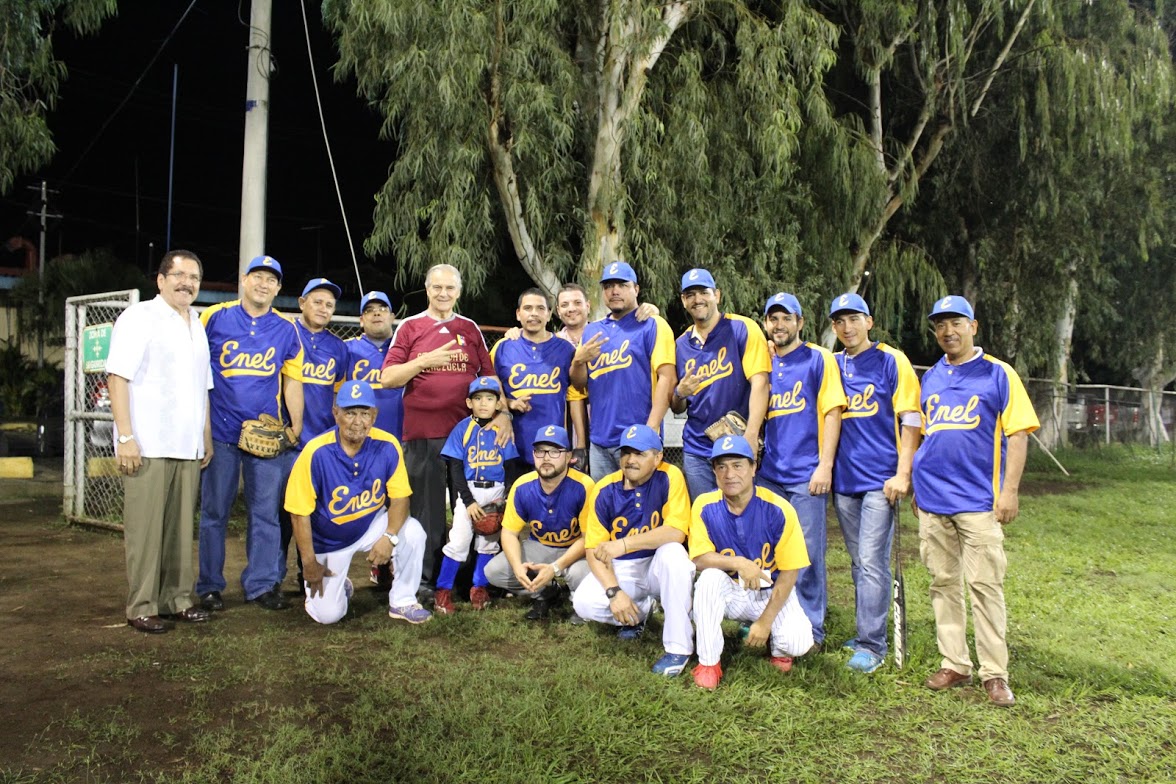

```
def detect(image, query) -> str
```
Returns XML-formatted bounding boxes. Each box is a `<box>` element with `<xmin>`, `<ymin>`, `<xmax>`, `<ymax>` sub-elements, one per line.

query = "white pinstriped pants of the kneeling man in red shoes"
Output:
<box><xmin>694</xmin><ymin>569</ymin><xmax>813</xmax><ymax>665</ymax></box>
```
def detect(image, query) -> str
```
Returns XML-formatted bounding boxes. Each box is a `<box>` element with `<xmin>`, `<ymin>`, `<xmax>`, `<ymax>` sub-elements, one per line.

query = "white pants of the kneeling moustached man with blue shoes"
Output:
<box><xmin>572</xmin><ymin>542</ymin><xmax>695</xmax><ymax>656</ymax></box>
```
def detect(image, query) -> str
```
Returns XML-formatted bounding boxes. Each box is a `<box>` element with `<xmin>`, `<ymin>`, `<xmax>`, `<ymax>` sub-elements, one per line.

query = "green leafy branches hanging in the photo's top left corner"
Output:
<box><xmin>0</xmin><ymin>0</ymin><xmax>118</xmax><ymax>193</ymax></box>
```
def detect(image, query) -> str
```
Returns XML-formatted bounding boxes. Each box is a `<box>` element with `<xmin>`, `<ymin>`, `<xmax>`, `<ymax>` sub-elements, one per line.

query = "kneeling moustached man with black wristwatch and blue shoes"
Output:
<box><xmin>572</xmin><ymin>424</ymin><xmax>694</xmax><ymax>676</ymax></box>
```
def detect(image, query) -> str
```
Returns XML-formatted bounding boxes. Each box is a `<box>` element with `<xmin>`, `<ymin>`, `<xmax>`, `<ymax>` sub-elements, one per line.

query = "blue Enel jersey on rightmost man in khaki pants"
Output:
<box><xmin>913</xmin><ymin>353</ymin><xmax>1041</xmax><ymax>515</ymax></box>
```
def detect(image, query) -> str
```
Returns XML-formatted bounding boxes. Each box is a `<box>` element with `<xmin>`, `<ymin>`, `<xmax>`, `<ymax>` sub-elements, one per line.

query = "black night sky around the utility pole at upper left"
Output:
<box><xmin>0</xmin><ymin>0</ymin><xmax>406</xmax><ymax>310</ymax></box>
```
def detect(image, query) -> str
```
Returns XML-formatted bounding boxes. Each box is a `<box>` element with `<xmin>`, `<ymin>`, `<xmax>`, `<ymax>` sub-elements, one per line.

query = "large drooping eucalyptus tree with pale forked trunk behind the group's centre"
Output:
<box><xmin>323</xmin><ymin>0</ymin><xmax>882</xmax><ymax>309</ymax></box>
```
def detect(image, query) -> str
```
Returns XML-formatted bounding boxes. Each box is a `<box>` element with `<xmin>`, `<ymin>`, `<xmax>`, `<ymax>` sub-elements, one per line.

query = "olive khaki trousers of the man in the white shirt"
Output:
<box><xmin>122</xmin><ymin>457</ymin><xmax>200</xmax><ymax>619</ymax></box>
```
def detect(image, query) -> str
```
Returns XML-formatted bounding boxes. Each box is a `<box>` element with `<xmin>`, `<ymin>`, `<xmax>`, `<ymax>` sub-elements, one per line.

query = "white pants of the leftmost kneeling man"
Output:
<box><xmin>302</xmin><ymin>510</ymin><xmax>425</xmax><ymax>623</ymax></box>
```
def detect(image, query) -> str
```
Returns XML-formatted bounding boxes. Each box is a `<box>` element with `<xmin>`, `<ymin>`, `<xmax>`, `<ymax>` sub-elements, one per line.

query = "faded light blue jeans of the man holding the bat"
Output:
<box><xmin>833</xmin><ymin>490</ymin><xmax>894</xmax><ymax>657</ymax></box>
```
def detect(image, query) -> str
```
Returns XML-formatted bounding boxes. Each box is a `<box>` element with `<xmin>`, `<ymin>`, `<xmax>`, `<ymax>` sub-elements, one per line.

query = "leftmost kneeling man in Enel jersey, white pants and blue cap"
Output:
<box><xmin>286</xmin><ymin>381</ymin><xmax>433</xmax><ymax>623</ymax></box>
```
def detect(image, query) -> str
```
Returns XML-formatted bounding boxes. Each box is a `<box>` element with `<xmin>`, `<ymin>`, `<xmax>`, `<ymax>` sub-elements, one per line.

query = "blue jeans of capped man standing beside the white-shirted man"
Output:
<box><xmin>196</xmin><ymin>441</ymin><xmax>294</xmax><ymax>602</ymax></box>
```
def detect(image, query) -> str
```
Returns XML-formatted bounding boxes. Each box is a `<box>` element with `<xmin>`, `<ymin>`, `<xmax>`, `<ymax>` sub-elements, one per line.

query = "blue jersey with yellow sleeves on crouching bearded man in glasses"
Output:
<box><xmin>502</xmin><ymin>471</ymin><xmax>593</xmax><ymax>548</ymax></box>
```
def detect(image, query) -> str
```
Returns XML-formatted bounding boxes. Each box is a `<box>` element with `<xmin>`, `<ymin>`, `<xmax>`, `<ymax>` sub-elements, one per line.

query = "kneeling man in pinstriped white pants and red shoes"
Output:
<box><xmin>690</xmin><ymin>436</ymin><xmax>813</xmax><ymax>689</ymax></box>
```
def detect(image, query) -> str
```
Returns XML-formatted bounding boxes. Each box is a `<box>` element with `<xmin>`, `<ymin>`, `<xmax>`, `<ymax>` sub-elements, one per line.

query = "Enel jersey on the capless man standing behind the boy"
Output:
<box><xmin>490</xmin><ymin>335</ymin><xmax>580</xmax><ymax>464</ymax></box>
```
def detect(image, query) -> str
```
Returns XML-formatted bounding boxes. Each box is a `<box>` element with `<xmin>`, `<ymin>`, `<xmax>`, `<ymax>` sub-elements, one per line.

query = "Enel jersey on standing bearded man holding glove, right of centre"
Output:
<box><xmin>675</xmin><ymin>314</ymin><xmax>771</xmax><ymax>458</ymax></box>
